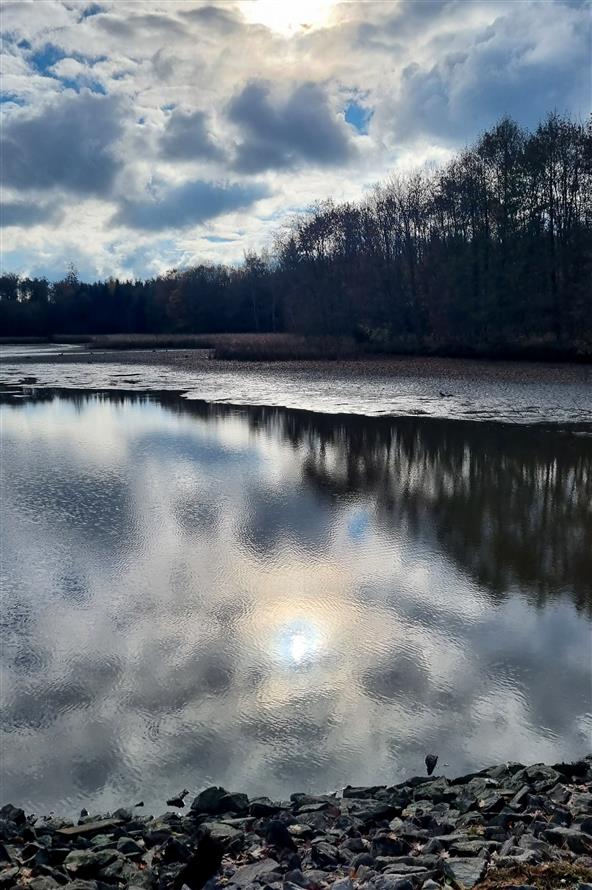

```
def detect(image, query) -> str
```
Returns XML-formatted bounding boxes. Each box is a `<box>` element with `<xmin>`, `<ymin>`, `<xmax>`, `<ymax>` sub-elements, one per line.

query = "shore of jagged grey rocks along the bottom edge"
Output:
<box><xmin>0</xmin><ymin>756</ymin><xmax>592</xmax><ymax>890</ymax></box>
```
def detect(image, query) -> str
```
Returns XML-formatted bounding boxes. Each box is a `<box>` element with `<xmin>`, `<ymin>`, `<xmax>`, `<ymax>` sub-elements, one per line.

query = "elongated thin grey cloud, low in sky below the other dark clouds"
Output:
<box><xmin>113</xmin><ymin>179</ymin><xmax>268</xmax><ymax>231</ymax></box>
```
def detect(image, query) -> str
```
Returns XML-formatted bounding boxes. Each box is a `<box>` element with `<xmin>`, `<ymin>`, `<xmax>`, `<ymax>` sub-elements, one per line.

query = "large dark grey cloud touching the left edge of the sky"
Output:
<box><xmin>0</xmin><ymin>90</ymin><xmax>122</xmax><ymax>197</ymax></box>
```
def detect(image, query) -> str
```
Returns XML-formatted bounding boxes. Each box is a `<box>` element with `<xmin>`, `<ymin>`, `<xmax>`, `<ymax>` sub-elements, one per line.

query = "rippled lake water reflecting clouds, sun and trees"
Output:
<box><xmin>0</xmin><ymin>389</ymin><xmax>592</xmax><ymax>813</ymax></box>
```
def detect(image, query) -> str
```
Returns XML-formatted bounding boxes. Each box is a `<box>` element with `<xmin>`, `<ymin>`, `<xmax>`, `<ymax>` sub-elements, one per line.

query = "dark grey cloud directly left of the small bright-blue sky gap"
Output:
<box><xmin>228</xmin><ymin>81</ymin><xmax>353</xmax><ymax>173</ymax></box>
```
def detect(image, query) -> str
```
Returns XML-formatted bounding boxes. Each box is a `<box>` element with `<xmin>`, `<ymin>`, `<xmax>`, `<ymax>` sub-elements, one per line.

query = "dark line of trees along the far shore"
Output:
<box><xmin>0</xmin><ymin>114</ymin><xmax>592</xmax><ymax>355</ymax></box>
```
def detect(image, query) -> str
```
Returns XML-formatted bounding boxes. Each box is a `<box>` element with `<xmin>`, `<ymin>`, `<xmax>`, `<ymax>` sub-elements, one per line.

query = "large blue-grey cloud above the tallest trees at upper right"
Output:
<box><xmin>383</xmin><ymin>4</ymin><xmax>589</xmax><ymax>145</ymax></box>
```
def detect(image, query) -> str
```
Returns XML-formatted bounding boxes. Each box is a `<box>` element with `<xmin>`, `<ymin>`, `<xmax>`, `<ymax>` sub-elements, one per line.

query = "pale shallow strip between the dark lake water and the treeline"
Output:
<box><xmin>0</xmin><ymin>348</ymin><xmax>592</xmax><ymax>424</ymax></box>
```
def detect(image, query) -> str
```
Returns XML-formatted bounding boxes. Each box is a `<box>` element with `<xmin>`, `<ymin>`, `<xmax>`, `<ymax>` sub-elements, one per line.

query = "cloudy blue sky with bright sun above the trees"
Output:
<box><xmin>0</xmin><ymin>0</ymin><xmax>591</xmax><ymax>280</ymax></box>
